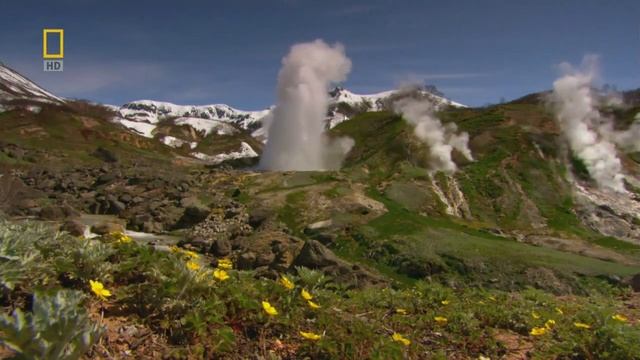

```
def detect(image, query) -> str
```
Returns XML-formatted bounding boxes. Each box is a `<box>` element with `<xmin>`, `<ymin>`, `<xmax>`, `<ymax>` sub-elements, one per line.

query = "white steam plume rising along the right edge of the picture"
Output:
<box><xmin>550</xmin><ymin>56</ymin><xmax>640</xmax><ymax>192</ymax></box>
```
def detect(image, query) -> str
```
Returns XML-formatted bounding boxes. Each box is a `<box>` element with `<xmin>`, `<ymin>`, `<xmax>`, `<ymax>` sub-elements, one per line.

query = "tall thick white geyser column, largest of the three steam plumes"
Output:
<box><xmin>260</xmin><ymin>40</ymin><xmax>354</xmax><ymax>170</ymax></box>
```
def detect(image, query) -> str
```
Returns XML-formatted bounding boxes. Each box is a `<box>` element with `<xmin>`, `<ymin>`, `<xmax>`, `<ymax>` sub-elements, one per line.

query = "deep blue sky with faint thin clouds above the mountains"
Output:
<box><xmin>0</xmin><ymin>0</ymin><xmax>640</xmax><ymax>109</ymax></box>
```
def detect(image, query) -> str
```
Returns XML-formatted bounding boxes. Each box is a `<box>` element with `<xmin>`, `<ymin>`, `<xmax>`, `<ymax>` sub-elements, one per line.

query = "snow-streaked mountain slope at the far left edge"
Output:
<box><xmin>0</xmin><ymin>63</ymin><xmax>64</xmax><ymax>106</ymax></box>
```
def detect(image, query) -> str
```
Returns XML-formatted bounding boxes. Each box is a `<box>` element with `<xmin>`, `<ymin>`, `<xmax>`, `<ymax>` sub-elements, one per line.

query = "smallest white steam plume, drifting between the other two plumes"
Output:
<box><xmin>394</xmin><ymin>98</ymin><xmax>473</xmax><ymax>173</ymax></box>
